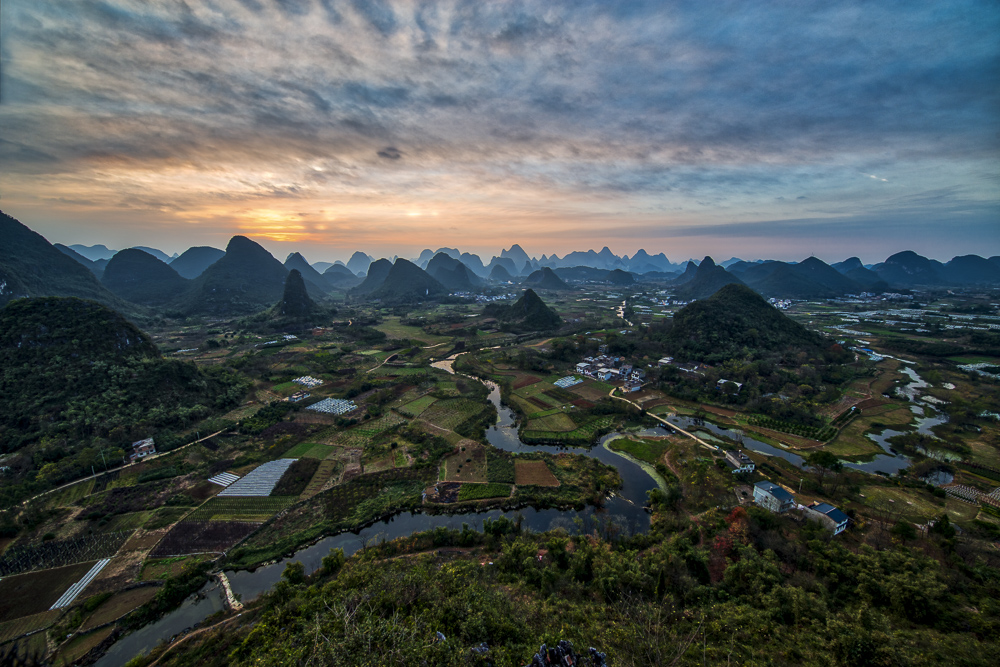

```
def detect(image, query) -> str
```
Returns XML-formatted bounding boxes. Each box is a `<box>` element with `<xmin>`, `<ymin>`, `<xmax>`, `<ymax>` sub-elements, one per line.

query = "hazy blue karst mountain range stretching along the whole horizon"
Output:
<box><xmin>0</xmin><ymin>214</ymin><xmax>1000</xmax><ymax>316</ymax></box>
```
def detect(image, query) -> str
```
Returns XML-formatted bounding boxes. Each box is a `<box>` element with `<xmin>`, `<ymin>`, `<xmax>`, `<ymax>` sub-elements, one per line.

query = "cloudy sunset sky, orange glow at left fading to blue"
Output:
<box><xmin>0</xmin><ymin>0</ymin><xmax>1000</xmax><ymax>262</ymax></box>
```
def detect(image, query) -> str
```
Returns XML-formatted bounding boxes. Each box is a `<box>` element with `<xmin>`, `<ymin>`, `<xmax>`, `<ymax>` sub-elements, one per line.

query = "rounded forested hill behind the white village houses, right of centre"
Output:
<box><xmin>664</xmin><ymin>284</ymin><xmax>822</xmax><ymax>362</ymax></box>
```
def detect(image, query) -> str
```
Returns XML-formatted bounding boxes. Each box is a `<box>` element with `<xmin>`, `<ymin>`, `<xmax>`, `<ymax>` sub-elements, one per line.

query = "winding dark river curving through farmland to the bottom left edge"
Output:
<box><xmin>96</xmin><ymin>355</ymin><xmax>665</xmax><ymax>667</ymax></box>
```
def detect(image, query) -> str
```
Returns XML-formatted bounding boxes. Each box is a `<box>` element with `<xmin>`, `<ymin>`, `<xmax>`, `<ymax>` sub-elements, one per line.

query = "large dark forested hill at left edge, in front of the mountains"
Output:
<box><xmin>0</xmin><ymin>297</ymin><xmax>243</xmax><ymax>468</ymax></box>
